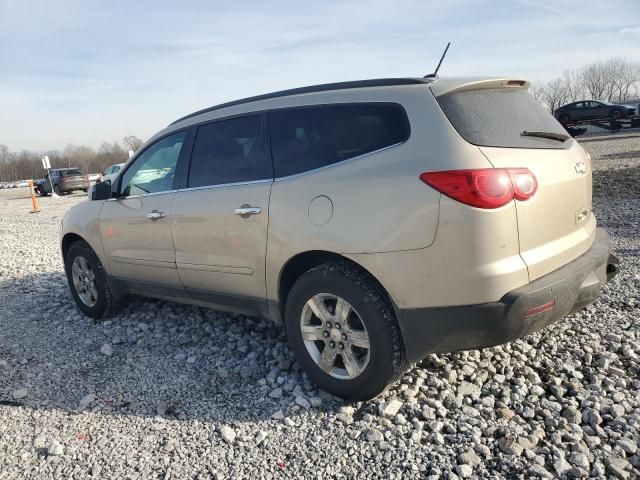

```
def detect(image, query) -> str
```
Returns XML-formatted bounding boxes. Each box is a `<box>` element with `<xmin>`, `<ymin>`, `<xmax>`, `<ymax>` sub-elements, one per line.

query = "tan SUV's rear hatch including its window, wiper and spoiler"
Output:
<box><xmin>431</xmin><ymin>80</ymin><xmax>596</xmax><ymax>281</ymax></box>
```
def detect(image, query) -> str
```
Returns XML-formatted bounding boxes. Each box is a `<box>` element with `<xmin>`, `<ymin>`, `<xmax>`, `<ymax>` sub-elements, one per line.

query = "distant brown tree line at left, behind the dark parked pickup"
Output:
<box><xmin>0</xmin><ymin>135</ymin><xmax>144</xmax><ymax>182</ymax></box>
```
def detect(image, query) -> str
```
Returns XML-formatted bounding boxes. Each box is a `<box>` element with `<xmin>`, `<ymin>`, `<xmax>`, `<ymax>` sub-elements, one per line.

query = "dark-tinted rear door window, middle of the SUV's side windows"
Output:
<box><xmin>187</xmin><ymin>114</ymin><xmax>273</xmax><ymax>188</ymax></box>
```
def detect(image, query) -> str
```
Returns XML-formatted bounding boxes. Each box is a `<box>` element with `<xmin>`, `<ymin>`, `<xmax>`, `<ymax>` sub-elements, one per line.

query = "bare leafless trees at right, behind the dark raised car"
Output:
<box><xmin>530</xmin><ymin>58</ymin><xmax>640</xmax><ymax>112</ymax></box>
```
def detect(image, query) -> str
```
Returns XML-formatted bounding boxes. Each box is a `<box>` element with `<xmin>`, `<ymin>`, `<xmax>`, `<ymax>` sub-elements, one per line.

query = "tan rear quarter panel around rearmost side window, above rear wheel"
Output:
<box><xmin>267</xmin><ymin>86</ymin><xmax>490</xmax><ymax>300</ymax></box>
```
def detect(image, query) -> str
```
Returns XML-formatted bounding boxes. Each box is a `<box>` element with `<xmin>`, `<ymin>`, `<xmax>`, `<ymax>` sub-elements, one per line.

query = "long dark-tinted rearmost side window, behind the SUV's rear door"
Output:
<box><xmin>269</xmin><ymin>103</ymin><xmax>410</xmax><ymax>177</ymax></box>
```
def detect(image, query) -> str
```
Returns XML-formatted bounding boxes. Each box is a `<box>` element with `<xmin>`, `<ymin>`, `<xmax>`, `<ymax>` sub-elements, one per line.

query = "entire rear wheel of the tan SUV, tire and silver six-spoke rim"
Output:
<box><xmin>285</xmin><ymin>263</ymin><xmax>407</xmax><ymax>400</ymax></box>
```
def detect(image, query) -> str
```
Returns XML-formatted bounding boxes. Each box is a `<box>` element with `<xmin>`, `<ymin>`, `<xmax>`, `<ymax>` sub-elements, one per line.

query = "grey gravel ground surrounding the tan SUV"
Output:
<box><xmin>0</xmin><ymin>135</ymin><xmax>640</xmax><ymax>479</ymax></box>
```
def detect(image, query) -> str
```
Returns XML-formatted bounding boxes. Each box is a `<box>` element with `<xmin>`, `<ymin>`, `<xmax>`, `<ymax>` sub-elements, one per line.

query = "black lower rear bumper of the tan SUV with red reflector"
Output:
<box><xmin>398</xmin><ymin>229</ymin><xmax>618</xmax><ymax>362</ymax></box>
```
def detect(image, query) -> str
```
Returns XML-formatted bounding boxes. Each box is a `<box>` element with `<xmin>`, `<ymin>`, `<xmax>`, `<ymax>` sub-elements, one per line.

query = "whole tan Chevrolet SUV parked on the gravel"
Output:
<box><xmin>61</xmin><ymin>78</ymin><xmax>617</xmax><ymax>399</ymax></box>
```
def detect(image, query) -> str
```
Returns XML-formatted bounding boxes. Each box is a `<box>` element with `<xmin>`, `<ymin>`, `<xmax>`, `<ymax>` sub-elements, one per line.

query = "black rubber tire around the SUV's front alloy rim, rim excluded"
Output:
<box><xmin>64</xmin><ymin>240</ymin><xmax>122</xmax><ymax>318</ymax></box>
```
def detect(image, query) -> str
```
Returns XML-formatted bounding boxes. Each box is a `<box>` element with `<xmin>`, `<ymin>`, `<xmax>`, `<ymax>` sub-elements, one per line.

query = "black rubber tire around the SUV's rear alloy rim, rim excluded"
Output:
<box><xmin>285</xmin><ymin>262</ymin><xmax>407</xmax><ymax>401</ymax></box>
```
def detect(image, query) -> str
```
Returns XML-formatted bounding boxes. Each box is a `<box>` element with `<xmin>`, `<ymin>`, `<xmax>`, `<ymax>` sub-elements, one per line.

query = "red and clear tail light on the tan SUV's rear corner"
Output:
<box><xmin>420</xmin><ymin>168</ymin><xmax>538</xmax><ymax>209</ymax></box>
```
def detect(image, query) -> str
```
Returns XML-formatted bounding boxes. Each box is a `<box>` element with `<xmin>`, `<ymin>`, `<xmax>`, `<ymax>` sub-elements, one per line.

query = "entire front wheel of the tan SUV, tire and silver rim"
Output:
<box><xmin>65</xmin><ymin>240</ymin><xmax>120</xmax><ymax>318</ymax></box>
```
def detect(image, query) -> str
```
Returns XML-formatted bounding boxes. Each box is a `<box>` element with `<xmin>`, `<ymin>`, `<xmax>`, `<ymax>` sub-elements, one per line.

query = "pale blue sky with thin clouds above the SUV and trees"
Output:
<box><xmin>0</xmin><ymin>0</ymin><xmax>640</xmax><ymax>151</ymax></box>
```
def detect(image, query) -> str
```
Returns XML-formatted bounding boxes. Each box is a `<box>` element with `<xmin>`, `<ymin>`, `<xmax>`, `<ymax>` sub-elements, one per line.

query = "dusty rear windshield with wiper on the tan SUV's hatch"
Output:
<box><xmin>436</xmin><ymin>88</ymin><xmax>571</xmax><ymax>149</ymax></box>
